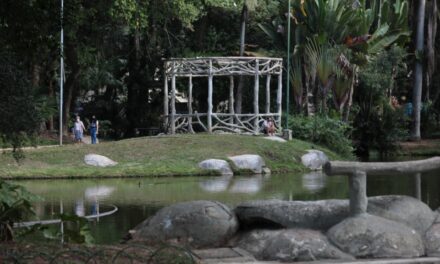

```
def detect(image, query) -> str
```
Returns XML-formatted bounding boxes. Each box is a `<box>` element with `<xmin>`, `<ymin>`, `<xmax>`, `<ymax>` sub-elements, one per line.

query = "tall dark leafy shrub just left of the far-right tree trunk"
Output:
<box><xmin>354</xmin><ymin>47</ymin><xmax>410</xmax><ymax>155</ymax></box>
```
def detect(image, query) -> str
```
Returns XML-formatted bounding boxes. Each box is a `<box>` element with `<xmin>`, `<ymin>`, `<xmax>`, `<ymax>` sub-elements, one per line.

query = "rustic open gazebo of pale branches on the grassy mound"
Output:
<box><xmin>164</xmin><ymin>57</ymin><xmax>283</xmax><ymax>134</ymax></box>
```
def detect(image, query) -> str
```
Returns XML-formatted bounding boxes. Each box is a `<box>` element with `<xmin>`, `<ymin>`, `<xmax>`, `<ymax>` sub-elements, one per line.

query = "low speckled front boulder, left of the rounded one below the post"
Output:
<box><xmin>235</xmin><ymin>229</ymin><xmax>353</xmax><ymax>262</ymax></box>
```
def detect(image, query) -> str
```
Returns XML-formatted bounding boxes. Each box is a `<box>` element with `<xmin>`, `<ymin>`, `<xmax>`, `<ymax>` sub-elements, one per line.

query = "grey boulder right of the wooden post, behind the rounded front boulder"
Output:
<box><xmin>367</xmin><ymin>195</ymin><xmax>435</xmax><ymax>235</ymax></box>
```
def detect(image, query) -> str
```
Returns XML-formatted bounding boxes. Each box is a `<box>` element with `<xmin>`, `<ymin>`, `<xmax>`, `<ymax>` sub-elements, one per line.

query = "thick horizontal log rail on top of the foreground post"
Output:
<box><xmin>324</xmin><ymin>157</ymin><xmax>440</xmax><ymax>176</ymax></box>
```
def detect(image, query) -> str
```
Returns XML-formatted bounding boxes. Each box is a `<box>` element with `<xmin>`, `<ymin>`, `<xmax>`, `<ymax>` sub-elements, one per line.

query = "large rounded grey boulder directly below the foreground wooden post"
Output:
<box><xmin>327</xmin><ymin>214</ymin><xmax>424</xmax><ymax>258</ymax></box>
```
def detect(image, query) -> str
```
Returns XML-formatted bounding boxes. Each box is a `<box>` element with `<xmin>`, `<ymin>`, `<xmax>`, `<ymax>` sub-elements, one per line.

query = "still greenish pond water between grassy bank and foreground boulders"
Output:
<box><xmin>15</xmin><ymin>171</ymin><xmax>440</xmax><ymax>244</ymax></box>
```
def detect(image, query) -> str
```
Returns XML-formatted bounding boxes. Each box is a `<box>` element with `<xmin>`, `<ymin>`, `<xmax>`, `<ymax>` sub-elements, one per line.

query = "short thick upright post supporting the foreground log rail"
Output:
<box><xmin>348</xmin><ymin>171</ymin><xmax>368</xmax><ymax>216</ymax></box>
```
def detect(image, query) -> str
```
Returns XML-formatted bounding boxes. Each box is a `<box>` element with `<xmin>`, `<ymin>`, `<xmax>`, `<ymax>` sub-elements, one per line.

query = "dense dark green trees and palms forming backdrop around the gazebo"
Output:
<box><xmin>0</xmin><ymin>0</ymin><xmax>440</xmax><ymax>156</ymax></box>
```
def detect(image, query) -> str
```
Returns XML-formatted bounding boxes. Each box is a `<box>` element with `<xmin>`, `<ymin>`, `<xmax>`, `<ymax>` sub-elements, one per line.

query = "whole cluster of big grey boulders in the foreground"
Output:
<box><xmin>130</xmin><ymin>196</ymin><xmax>440</xmax><ymax>261</ymax></box>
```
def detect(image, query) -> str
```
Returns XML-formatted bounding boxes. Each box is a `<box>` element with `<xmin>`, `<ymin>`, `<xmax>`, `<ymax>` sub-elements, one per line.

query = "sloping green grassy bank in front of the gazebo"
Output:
<box><xmin>0</xmin><ymin>134</ymin><xmax>348</xmax><ymax>178</ymax></box>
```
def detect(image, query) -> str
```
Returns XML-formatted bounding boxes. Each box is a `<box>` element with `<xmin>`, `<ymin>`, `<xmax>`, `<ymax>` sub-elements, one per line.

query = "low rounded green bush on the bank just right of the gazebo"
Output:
<box><xmin>289</xmin><ymin>115</ymin><xmax>353</xmax><ymax>157</ymax></box>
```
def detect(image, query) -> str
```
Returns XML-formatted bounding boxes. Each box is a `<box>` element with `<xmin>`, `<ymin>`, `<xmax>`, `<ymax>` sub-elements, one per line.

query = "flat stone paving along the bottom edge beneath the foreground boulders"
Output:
<box><xmin>193</xmin><ymin>248</ymin><xmax>440</xmax><ymax>264</ymax></box>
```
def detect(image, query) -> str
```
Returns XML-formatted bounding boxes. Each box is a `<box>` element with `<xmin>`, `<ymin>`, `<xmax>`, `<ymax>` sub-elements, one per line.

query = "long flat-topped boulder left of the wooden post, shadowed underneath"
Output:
<box><xmin>234</xmin><ymin>200</ymin><xmax>349</xmax><ymax>230</ymax></box>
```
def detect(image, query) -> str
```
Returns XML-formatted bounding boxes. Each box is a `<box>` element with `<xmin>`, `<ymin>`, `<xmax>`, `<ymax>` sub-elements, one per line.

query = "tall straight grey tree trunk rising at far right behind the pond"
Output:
<box><xmin>411</xmin><ymin>0</ymin><xmax>426</xmax><ymax>141</ymax></box>
